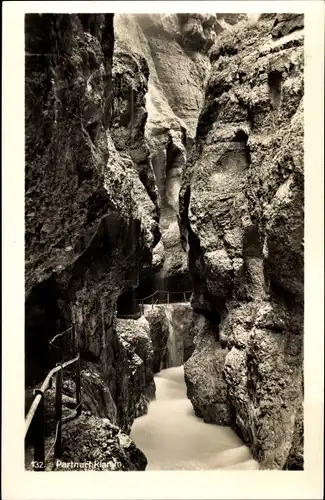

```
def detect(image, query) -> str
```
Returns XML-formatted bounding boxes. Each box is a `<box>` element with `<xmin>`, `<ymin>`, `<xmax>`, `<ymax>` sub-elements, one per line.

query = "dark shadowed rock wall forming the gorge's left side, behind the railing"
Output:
<box><xmin>25</xmin><ymin>14</ymin><xmax>160</xmax><ymax>466</ymax></box>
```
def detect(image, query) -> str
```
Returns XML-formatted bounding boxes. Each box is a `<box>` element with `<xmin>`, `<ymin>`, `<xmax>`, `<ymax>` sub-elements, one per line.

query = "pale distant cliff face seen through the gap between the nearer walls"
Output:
<box><xmin>115</xmin><ymin>14</ymin><xmax>233</xmax><ymax>290</ymax></box>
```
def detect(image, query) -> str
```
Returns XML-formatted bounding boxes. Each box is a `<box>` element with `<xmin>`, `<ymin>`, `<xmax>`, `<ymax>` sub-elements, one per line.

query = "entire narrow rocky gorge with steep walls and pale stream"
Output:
<box><xmin>25</xmin><ymin>14</ymin><xmax>304</xmax><ymax>471</ymax></box>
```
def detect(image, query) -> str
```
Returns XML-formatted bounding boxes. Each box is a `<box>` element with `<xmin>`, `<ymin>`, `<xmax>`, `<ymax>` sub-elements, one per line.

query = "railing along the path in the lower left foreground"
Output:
<box><xmin>25</xmin><ymin>329</ymin><xmax>81</xmax><ymax>471</ymax></box>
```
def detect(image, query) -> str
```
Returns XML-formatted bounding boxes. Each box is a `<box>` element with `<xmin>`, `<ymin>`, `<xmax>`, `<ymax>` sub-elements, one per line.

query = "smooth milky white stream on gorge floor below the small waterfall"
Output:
<box><xmin>131</xmin><ymin>366</ymin><xmax>258</xmax><ymax>470</ymax></box>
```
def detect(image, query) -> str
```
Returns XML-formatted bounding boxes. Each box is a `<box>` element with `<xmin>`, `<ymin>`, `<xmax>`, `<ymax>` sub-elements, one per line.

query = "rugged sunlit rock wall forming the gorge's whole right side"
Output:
<box><xmin>180</xmin><ymin>14</ymin><xmax>304</xmax><ymax>469</ymax></box>
